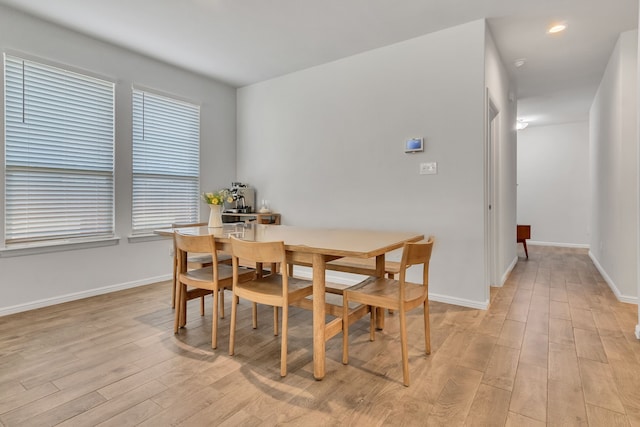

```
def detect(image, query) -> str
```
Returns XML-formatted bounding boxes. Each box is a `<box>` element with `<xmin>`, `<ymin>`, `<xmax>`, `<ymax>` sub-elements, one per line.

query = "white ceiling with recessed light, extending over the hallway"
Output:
<box><xmin>0</xmin><ymin>0</ymin><xmax>638</xmax><ymax>126</ymax></box>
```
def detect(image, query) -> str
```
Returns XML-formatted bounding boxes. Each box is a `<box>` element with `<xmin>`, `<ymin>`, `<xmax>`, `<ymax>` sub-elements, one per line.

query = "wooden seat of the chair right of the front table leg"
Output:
<box><xmin>343</xmin><ymin>277</ymin><xmax>425</xmax><ymax>310</ymax></box>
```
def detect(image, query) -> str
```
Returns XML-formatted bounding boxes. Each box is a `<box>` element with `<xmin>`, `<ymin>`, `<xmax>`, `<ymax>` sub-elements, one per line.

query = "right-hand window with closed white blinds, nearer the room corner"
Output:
<box><xmin>132</xmin><ymin>89</ymin><xmax>200</xmax><ymax>234</ymax></box>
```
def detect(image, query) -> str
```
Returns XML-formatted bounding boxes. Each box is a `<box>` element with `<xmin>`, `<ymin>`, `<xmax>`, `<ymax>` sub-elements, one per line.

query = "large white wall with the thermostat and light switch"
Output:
<box><xmin>238</xmin><ymin>21</ymin><xmax>515</xmax><ymax>307</ymax></box>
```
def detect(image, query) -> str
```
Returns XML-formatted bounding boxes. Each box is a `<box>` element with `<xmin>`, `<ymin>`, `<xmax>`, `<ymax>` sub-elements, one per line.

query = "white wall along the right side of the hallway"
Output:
<box><xmin>589</xmin><ymin>31</ymin><xmax>638</xmax><ymax>302</ymax></box>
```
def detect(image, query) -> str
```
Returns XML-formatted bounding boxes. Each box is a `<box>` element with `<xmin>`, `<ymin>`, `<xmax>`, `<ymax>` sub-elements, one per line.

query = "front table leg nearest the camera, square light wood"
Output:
<box><xmin>313</xmin><ymin>254</ymin><xmax>326</xmax><ymax>380</ymax></box>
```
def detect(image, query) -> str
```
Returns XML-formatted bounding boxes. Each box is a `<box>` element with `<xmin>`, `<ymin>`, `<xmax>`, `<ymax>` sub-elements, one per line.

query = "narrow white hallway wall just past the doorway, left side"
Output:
<box><xmin>485</xmin><ymin>27</ymin><xmax>518</xmax><ymax>286</ymax></box>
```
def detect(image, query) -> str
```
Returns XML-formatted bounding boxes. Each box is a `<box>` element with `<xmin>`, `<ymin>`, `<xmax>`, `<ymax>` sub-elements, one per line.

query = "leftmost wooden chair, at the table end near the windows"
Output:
<box><xmin>173</xmin><ymin>231</ymin><xmax>255</xmax><ymax>348</ymax></box>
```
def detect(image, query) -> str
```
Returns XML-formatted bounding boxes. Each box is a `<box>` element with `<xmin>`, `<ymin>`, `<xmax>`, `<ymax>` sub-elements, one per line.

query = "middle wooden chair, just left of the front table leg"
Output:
<box><xmin>229</xmin><ymin>237</ymin><xmax>313</xmax><ymax>377</ymax></box>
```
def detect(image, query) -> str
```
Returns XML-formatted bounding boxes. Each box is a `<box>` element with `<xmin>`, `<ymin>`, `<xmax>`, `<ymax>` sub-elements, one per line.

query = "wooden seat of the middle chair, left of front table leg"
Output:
<box><xmin>235</xmin><ymin>274</ymin><xmax>313</xmax><ymax>307</ymax></box>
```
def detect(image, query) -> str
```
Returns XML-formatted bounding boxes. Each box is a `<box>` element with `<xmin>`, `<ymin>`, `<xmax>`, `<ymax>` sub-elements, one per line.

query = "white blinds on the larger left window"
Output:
<box><xmin>4</xmin><ymin>55</ymin><xmax>114</xmax><ymax>245</ymax></box>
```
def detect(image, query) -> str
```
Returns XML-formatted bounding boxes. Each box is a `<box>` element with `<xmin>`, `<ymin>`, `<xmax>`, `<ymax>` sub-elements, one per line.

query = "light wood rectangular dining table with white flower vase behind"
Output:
<box><xmin>155</xmin><ymin>223</ymin><xmax>424</xmax><ymax>380</ymax></box>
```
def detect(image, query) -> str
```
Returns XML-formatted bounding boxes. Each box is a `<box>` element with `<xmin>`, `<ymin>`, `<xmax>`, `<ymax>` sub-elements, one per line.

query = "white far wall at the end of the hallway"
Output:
<box><xmin>518</xmin><ymin>121</ymin><xmax>591</xmax><ymax>247</ymax></box>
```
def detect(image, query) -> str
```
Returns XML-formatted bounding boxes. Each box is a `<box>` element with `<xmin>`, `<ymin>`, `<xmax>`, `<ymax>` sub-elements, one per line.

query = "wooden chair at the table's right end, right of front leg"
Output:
<box><xmin>342</xmin><ymin>237</ymin><xmax>433</xmax><ymax>386</ymax></box>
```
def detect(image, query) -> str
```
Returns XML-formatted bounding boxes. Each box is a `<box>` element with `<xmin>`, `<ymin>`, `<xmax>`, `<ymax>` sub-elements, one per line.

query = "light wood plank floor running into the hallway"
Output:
<box><xmin>0</xmin><ymin>246</ymin><xmax>640</xmax><ymax>426</ymax></box>
